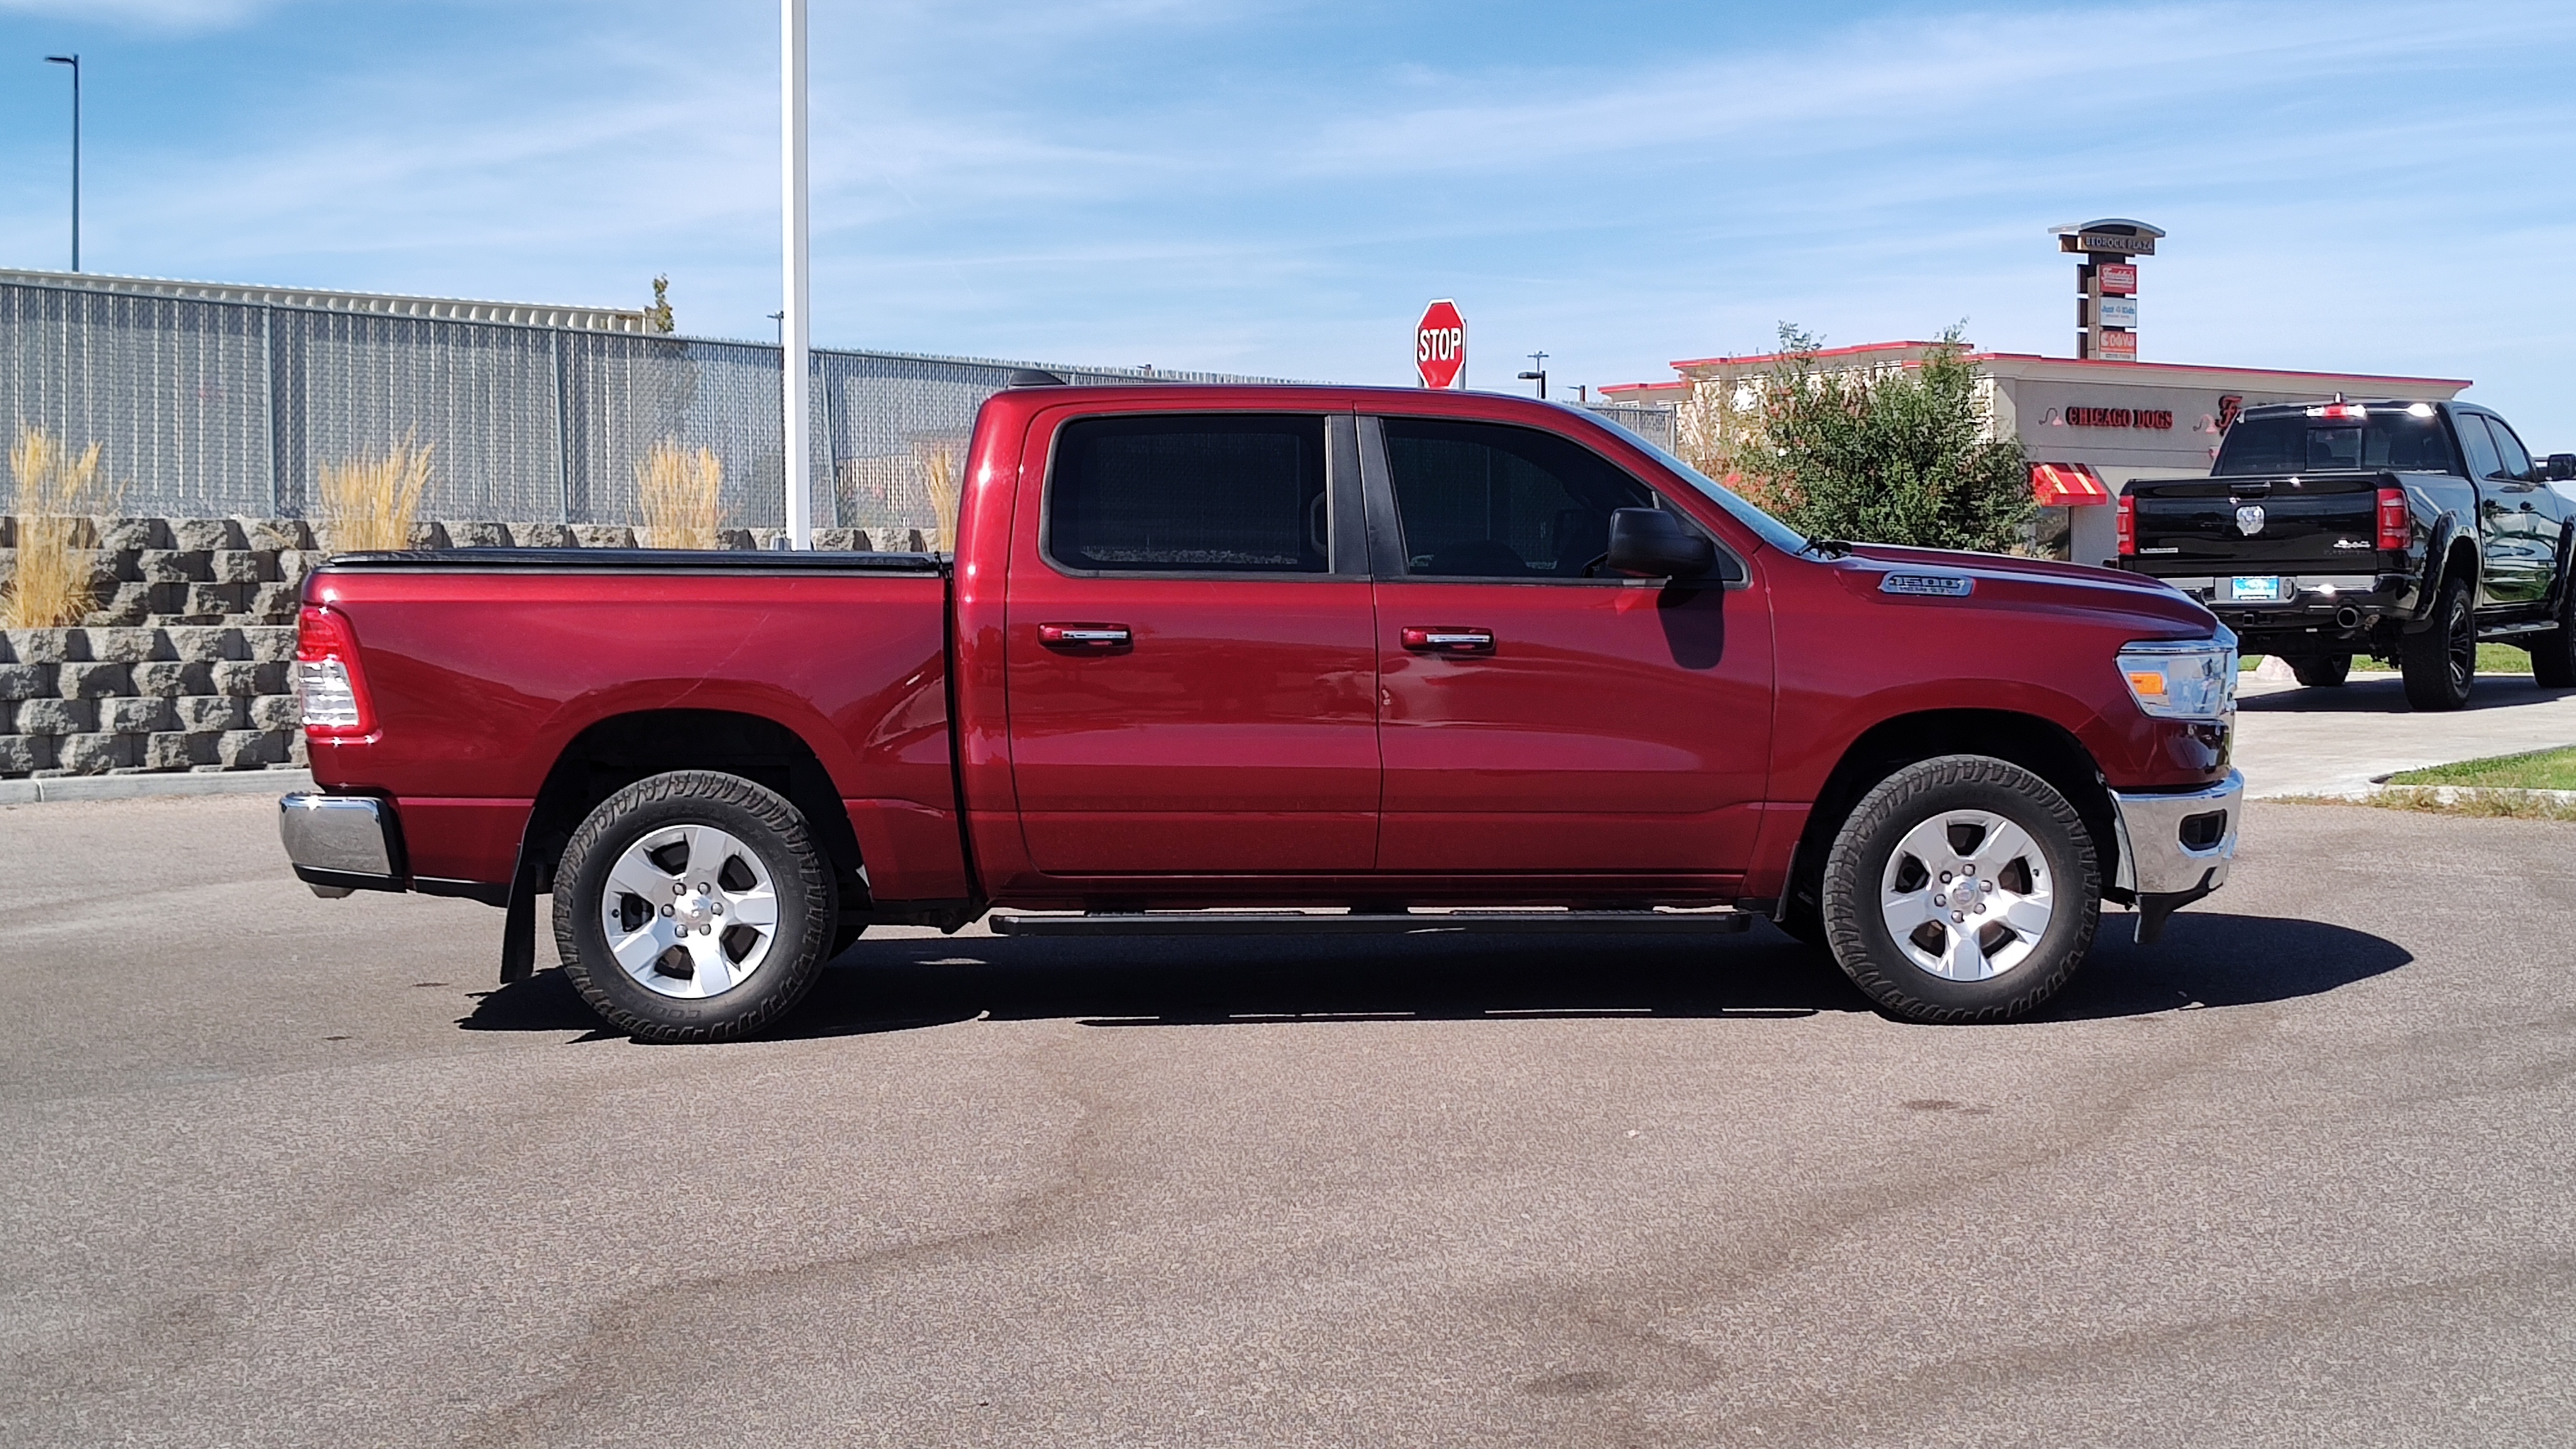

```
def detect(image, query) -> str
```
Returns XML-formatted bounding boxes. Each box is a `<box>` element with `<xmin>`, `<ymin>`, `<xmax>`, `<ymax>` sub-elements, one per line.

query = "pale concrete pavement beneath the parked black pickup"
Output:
<box><xmin>2236</xmin><ymin>673</ymin><xmax>2576</xmax><ymax>797</ymax></box>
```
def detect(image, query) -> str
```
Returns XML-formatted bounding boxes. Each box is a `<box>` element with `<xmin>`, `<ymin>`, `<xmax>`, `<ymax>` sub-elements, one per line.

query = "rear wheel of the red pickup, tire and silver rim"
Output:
<box><xmin>554</xmin><ymin>771</ymin><xmax>835</xmax><ymax>1041</ymax></box>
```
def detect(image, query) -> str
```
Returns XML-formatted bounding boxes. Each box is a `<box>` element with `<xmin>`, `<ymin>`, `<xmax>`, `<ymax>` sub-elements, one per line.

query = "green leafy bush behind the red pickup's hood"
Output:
<box><xmin>1741</xmin><ymin>322</ymin><xmax>2035</xmax><ymax>554</ymax></box>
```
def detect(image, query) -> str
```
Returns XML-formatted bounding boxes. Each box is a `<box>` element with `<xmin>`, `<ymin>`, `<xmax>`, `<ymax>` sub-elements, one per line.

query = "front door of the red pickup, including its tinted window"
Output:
<box><xmin>1360</xmin><ymin>418</ymin><xmax>1772</xmax><ymax>876</ymax></box>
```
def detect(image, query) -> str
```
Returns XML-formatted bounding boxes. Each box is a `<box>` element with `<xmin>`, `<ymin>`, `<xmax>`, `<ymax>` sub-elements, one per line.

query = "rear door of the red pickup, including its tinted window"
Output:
<box><xmin>1002</xmin><ymin>410</ymin><xmax>1378</xmax><ymax>877</ymax></box>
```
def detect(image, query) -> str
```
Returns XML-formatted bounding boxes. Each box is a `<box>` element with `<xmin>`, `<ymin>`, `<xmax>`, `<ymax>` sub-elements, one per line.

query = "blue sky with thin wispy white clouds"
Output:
<box><xmin>0</xmin><ymin>0</ymin><xmax>2576</xmax><ymax>448</ymax></box>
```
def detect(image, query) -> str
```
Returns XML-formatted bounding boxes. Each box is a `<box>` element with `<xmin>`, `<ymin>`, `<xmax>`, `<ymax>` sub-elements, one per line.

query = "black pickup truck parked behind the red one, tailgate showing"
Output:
<box><xmin>2118</xmin><ymin>397</ymin><xmax>2576</xmax><ymax>709</ymax></box>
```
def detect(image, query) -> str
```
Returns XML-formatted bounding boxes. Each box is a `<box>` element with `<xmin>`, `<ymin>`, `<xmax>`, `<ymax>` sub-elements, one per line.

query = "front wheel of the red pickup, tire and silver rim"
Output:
<box><xmin>1824</xmin><ymin>755</ymin><xmax>2102</xmax><ymax>1021</ymax></box>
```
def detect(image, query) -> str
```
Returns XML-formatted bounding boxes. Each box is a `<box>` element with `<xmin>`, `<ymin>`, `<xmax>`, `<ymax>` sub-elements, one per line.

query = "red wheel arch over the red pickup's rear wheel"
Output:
<box><xmin>520</xmin><ymin>709</ymin><xmax>868</xmax><ymax>908</ymax></box>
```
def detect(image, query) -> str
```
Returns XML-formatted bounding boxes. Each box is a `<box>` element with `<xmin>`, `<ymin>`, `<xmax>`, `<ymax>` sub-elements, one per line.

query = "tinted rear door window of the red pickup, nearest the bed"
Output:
<box><xmin>1046</xmin><ymin>413</ymin><xmax>1332</xmax><ymax>575</ymax></box>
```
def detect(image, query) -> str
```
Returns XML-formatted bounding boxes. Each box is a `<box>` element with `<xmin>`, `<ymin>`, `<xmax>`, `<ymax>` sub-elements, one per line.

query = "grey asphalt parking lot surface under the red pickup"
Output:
<box><xmin>0</xmin><ymin>799</ymin><xmax>2576</xmax><ymax>1449</ymax></box>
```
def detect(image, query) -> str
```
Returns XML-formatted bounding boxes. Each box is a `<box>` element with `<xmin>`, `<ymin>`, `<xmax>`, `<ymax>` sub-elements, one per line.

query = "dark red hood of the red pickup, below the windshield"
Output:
<box><xmin>1831</xmin><ymin>544</ymin><xmax>2218</xmax><ymax>640</ymax></box>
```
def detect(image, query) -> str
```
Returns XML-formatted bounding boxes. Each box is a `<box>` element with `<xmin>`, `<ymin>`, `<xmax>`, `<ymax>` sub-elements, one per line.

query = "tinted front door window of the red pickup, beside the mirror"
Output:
<box><xmin>1384</xmin><ymin>418</ymin><xmax>1654</xmax><ymax>580</ymax></box>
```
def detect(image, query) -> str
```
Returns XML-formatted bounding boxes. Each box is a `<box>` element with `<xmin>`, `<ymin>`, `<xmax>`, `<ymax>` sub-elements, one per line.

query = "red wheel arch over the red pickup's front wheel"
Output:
<box><xmin>1780</xmin><ymin>709</ymin><xmax>2120</xmax><ymax>915</ymax></box>
